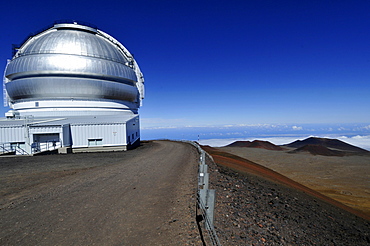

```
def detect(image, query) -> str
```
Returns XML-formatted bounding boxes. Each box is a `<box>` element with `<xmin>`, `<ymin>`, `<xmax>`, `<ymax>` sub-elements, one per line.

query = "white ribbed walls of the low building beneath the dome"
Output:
<box><xmin>0</xmin><ymin>115</ymin><xmax>140</xmax><ymax>153</ymax></box>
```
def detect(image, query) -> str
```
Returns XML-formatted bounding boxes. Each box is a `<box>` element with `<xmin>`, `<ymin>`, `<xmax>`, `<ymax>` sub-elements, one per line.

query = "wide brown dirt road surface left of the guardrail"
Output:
<box><xmin>0</xmin><ymin>141</ymin><xmax>199</xmax><ymax>245</ymax></box>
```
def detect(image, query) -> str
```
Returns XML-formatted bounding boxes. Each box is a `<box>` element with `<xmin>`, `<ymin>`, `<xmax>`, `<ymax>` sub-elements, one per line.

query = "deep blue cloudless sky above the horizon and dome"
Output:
<box><xmin>0</xmin><ymin>0</ymin><xmax>370</xmax><ymax>127</ymax></box>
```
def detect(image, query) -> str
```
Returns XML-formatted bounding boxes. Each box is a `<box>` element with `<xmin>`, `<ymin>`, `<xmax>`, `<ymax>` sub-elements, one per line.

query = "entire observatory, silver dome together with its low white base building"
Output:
<box><xmin>0</xmin><ymin>22</ymin><xmax>144</xmax><ymax>154</ymax></box>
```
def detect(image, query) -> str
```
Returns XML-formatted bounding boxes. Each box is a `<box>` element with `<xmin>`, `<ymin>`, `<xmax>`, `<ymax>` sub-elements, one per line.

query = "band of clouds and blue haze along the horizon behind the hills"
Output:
<box><xmin>141</xmin><ymin>123</ymin><xmax>370</xmax><ymax>150</ymax></box>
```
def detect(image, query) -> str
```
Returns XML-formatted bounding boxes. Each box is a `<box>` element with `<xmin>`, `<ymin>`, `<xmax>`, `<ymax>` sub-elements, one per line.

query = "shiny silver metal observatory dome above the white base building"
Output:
<box><xmin>4</xmin><ymin>23</ymin><xmax>144</xmax><ymax>116</ymax></box>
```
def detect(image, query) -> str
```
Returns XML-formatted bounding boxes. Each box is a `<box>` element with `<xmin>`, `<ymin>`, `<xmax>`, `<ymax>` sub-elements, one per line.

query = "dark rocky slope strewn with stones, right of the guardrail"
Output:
<box><xmin>207</xmin><ymin>147</ymin><xmax>370</xmax><ymax>245</ymax></box>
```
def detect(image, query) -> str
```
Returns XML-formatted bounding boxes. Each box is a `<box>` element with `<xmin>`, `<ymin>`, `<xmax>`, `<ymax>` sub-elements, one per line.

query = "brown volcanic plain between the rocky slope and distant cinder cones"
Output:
<box><xmin>218</xmin><ymin>144</ymin><xmax>370</xmax><ymax>216</ymax></box>
